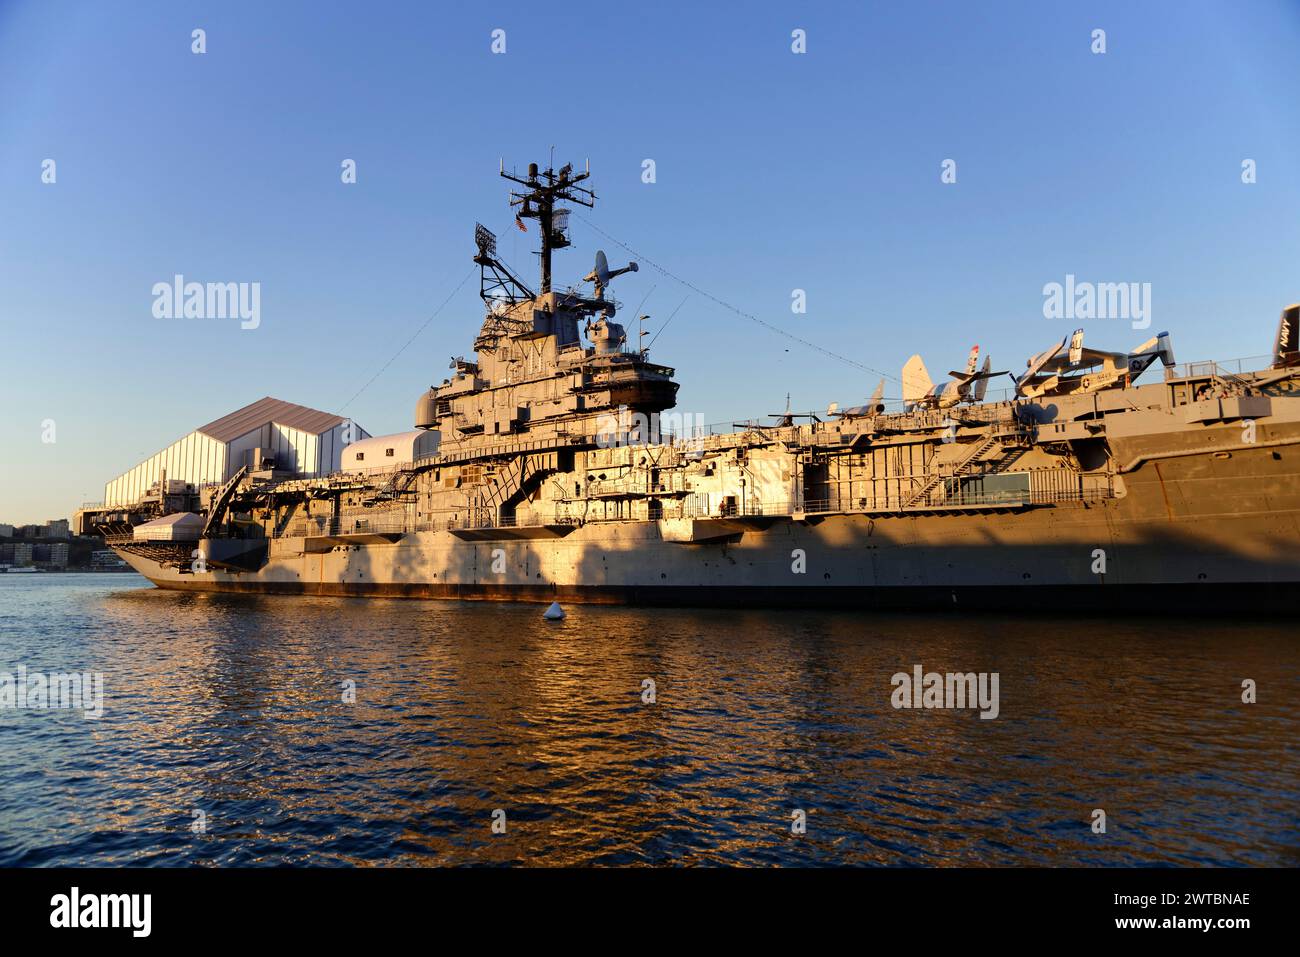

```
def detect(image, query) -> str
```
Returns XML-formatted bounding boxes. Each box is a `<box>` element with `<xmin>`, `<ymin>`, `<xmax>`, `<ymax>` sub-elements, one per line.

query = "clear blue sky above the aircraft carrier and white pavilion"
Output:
<box><xmin>0</xmin><ymin>0</ymin><xmax>1300</xmax><ymax>521</ymax></box>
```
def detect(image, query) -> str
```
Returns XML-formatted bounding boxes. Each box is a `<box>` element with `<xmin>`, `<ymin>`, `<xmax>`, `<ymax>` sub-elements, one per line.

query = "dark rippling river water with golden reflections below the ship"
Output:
<box><xmin>0</xmin><ymin>573</ymin><xmax>1300</xmax><ymax>866</ymax></box>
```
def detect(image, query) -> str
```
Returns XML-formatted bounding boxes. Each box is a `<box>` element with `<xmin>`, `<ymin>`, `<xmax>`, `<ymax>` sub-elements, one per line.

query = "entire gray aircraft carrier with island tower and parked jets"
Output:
<box><xmin>77</xmin><ymin>164</ymin><xmax>1300</xmax><ymax>615</ymax></box>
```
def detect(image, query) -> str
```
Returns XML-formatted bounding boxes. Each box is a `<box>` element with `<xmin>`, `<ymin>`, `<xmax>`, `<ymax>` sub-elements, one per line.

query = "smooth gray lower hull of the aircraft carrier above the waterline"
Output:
<box><xmin>116</xmin><ymin>441</ymin><xmax>1300</xmax><ymax>615</ymax></box>
